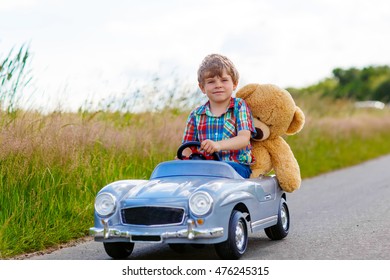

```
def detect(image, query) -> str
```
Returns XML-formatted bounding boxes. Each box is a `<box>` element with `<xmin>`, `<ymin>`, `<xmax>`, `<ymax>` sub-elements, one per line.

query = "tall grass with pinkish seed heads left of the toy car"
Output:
<box><xmin>0</xmin><ymin>110</ymin><xmax>180</xmax><ymax>258</ymax></box>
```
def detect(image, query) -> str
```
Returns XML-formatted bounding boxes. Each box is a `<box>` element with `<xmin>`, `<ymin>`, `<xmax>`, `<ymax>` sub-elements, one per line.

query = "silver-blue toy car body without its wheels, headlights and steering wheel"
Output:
<box><xmin>90</xmin><ymin>160</ymin><xmax>285</xmax><ymax>244</ymax></box>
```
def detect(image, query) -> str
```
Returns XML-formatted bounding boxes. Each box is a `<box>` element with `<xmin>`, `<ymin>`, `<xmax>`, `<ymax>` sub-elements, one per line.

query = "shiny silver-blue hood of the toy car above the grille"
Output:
<box><xmin>124</xmin><ymin>177</ymin><xmax>220</xmax><ymax>199</ymax></box>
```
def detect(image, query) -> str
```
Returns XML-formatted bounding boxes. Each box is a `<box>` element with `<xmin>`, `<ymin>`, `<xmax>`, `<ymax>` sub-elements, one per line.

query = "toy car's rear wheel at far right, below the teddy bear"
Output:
<box><xmin>264</xmin><ymin>198</ymin><xmax>290</xmax><ymax>240</ymax></box>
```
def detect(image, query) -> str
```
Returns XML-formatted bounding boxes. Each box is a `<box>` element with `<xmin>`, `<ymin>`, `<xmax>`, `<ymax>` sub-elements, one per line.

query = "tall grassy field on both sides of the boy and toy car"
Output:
<box><xmin>0</xmin><ymin>97</ymin><xmax>390</xmax><ymax>258</ymax></box>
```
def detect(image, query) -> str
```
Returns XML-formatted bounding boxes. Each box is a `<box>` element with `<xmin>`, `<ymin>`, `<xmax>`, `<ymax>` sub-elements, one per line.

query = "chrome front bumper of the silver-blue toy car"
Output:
<box><xmin>89</xmin><ymin>219</ymin><xmax>223</xmax><ymax>243</ymax></box>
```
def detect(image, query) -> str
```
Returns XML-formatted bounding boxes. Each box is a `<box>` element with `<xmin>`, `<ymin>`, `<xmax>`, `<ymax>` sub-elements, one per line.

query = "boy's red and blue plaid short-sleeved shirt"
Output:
<box><xmin>182</xmin><ymin>98</ymin><xmax>256</xmax><ymax>165</ymax></box>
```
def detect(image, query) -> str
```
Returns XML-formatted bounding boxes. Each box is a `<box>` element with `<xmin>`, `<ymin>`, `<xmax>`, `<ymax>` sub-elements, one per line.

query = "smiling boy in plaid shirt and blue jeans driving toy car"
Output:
<box><xmin>182</xmin><ymin>54</ymin><xmax>256</xmax><ymax>178</ymax></box>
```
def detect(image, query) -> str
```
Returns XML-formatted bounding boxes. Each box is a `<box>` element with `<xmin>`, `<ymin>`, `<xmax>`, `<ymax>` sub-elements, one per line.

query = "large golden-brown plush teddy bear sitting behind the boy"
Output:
<box><xmin>236</xmin><ymin>84</ymin><xmax>305</xmax><ymax>192</ymax></box>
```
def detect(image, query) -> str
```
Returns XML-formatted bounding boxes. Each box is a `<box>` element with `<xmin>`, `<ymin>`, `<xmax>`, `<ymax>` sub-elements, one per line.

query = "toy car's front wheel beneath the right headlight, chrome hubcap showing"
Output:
<box><xmin>215</xmin><ymin>210</ymin><xmax>248</xmax><ymax>260</ymax></box>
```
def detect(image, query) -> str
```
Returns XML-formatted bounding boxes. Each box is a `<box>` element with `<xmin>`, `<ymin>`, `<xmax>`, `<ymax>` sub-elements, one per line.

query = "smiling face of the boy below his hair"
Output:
<box><xmin>199</xmin><ymin>69</ymin><xmax>237</xmax><ymax>103</ymax></box>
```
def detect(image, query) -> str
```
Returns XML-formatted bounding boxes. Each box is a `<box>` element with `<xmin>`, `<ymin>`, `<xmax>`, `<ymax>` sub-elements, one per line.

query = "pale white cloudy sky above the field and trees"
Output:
<box><xmin>0</xmin><ymin>0</ymin><xmax>390</xmax><ymax>110</ymax></box>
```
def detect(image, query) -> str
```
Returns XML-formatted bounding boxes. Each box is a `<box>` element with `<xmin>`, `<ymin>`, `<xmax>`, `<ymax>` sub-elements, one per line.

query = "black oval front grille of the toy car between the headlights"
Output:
<box><xmin>122</xmin><ymin>206</ymin><xmax>184</xmax><ymax>226</ymax></box>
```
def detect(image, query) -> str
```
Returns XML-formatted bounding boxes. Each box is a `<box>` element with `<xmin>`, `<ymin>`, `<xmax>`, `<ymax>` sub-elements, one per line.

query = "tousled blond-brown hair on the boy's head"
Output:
<box><xmin>198</xmin><ymin>54</ymin><xmax>240</xmax><ymax>84</ymax></box>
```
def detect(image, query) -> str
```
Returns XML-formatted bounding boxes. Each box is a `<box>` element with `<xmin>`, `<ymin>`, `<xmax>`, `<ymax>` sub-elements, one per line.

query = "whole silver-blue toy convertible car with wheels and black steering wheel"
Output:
<box><xmin>90</xmin><ymin>142</ymin><xmax>290</xmax><ymax>259</ymax></box>
